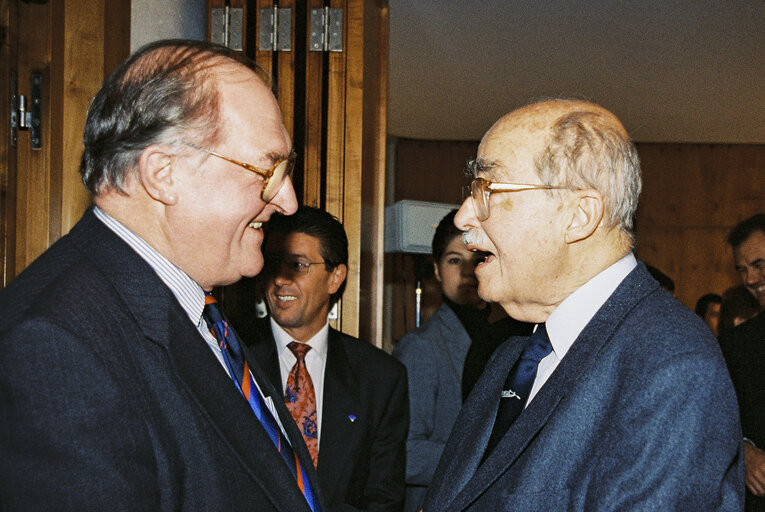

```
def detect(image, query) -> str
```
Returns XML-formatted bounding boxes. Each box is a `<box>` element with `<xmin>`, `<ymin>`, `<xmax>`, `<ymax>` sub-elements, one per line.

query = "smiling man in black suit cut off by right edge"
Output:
<box><xmin>720</xmin><ymin>213</ymin><xmax>765</xmax><ymax>512</ymax></box>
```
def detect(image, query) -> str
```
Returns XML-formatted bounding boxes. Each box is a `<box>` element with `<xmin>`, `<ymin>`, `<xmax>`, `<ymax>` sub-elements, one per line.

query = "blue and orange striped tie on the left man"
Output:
<box><xmin>203</xmin><ymin>292</ymin><xmax>321</xmax><ymax>512</ymax></box>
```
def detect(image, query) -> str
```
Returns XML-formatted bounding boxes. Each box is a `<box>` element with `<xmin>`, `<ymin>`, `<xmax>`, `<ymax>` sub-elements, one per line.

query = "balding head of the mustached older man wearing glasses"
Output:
<box><xmin>455</xmin><ymin>100</ymin><xmax>641</xmax><ymax>322</ymax></box>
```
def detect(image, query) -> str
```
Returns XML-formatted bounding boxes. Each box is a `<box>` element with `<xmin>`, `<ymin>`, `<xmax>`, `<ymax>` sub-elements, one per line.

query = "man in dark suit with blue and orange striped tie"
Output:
<box><xmin>0</xmin><ymin>41</ymin><xmax>321</xmax><ymax>512</ymax></box>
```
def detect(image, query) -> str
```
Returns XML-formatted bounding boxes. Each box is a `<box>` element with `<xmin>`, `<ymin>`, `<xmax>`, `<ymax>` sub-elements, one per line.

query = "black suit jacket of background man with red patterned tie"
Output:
<box><xmin>242</xmin><ymin>318</ymin><xmax>409</xmax><ymax>512</ymax></box>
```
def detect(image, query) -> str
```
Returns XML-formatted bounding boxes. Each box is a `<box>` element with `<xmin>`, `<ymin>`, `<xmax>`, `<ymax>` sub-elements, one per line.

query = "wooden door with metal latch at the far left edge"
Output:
<box><xmin>0</xmin><ymin>0</ymin><xmax>130</xmax><ymax>286</ymax></box>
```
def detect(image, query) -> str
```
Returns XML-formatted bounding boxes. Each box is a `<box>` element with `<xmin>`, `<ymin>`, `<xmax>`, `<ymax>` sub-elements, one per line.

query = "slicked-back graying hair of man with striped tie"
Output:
<box><xmin>80</xmin><ymin>40</ymin><xmax>269</xmax><ymax>195</ymax></box>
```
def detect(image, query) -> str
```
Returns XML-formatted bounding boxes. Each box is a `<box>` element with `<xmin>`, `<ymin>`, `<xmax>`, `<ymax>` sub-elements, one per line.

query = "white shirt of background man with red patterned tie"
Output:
<box><xmin>269</xmin><ymin>317</ymin><xmax>329</xmax><ymax>441</ymax></box>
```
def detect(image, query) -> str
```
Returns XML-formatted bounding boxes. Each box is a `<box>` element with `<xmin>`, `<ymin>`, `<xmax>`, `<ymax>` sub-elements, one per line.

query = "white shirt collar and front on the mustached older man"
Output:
<box><xmin>526</xmin><ymin>253</ymin><xmax>637</xmax><ymax>405</ymax></box>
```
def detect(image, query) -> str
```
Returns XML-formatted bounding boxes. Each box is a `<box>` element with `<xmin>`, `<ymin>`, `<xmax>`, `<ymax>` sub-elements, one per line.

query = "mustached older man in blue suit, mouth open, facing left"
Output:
<box><xmin>424</xmin><ymin>100</ymin><xmax>743</xmax><ymax>512</ymax></box>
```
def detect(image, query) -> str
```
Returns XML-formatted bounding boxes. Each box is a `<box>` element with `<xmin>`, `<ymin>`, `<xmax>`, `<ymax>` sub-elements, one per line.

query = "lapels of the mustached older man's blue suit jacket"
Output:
<box><xmin>450</xmin><ymin>263</ymin><xmax>658</xmax><ymax>510</ymax></box>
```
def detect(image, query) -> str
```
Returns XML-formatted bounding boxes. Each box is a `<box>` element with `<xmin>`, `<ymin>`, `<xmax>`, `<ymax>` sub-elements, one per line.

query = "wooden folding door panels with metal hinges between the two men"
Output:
<box><xmin>208</xmin><ymin>0</ymin><xmax>388</xmax><ymax>346</ymax></box>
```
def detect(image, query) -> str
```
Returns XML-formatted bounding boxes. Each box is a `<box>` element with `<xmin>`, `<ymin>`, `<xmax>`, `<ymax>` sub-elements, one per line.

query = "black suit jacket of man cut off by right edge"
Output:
<box><xmin>720</xmin><ymin>313</ymin><xmax>765</xmax><ymax>512</ymax></box>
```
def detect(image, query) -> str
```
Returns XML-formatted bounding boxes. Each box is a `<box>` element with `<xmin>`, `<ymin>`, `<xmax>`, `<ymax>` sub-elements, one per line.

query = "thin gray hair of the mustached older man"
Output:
<box><xmin>535</xmin><ymin>108</ymin><xmax>642</xmax><ymax>245</ymax></box>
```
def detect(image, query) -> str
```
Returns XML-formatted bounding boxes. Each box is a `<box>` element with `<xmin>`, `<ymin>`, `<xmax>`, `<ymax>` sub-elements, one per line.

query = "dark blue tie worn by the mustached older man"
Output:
<box><xmin>483</xmin><ymin>324</ymin><xmax>552</xmax><ymax>459</ymax></box>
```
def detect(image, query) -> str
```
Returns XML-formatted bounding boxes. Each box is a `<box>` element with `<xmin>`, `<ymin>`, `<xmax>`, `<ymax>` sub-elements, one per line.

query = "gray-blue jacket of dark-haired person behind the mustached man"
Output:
<box><xmin>393</xmin><ymin>304</ymin><xmax>470</xmax><ymax>512</ymax></box>
